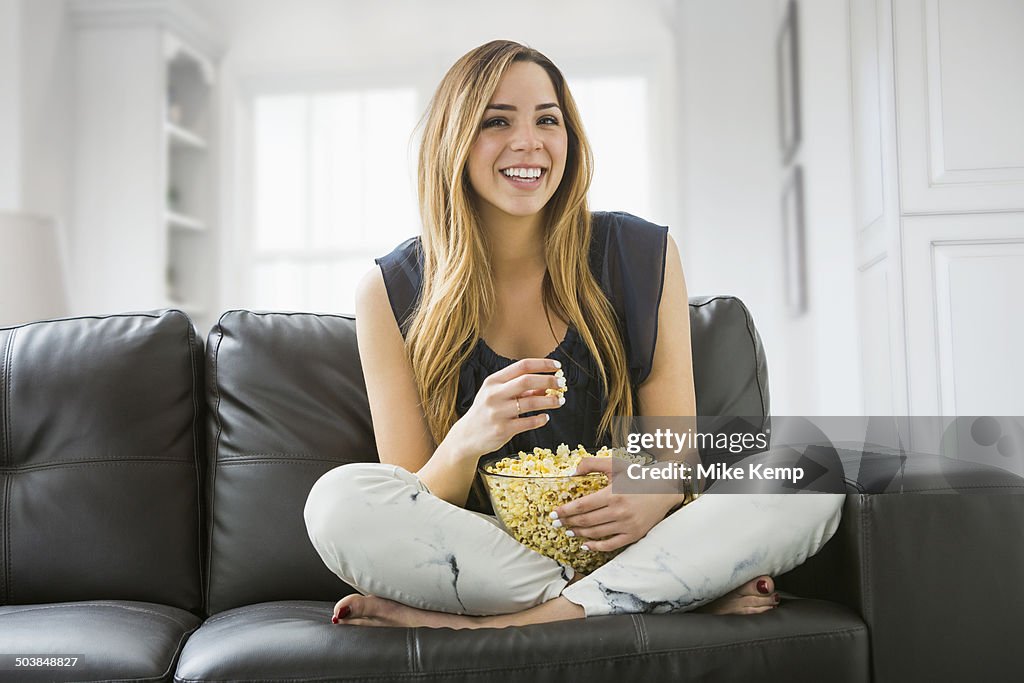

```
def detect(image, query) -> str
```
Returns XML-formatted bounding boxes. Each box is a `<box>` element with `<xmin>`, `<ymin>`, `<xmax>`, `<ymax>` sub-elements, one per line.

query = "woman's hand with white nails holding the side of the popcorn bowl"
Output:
<box><xmin>555</xmin><ymin>458</ymin><xmax>683</xmax><ymax>551</ymax></box>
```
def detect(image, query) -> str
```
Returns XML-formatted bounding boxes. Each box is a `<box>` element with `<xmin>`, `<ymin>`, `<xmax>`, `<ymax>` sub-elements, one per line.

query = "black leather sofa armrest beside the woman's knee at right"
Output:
<box><xmin>777</xmin><ymin>451</ymin><xmax>1024</xmax><ymax>682</ymax></box>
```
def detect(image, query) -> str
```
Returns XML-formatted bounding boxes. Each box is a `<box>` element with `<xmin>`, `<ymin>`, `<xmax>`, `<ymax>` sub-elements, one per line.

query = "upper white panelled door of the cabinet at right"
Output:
<box><xmin>893</xmin><ymin>0</ymin><xmax>1024</xmax><ymax>213</ymax></box>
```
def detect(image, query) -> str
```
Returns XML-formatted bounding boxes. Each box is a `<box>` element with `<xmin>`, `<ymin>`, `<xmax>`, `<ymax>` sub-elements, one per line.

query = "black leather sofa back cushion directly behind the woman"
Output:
<box><xmin>207</xmin><ymin>297</ymin><xmax>768</xmax><ymax>613</ymax></box>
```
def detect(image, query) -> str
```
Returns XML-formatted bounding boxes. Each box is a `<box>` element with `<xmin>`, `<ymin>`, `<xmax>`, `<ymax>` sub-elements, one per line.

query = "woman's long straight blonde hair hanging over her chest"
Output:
<box><xmin>406</xmin><ymin>40</ymin><xmax>633</xmax><ymax>445</ymax></box>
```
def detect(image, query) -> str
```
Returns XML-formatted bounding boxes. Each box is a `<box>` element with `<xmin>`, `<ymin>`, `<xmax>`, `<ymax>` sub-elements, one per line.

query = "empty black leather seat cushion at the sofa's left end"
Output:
<box><xmin>0</xmin><ymin>600</ymin><xmax>202</xmax><ymax>681</ymax></box>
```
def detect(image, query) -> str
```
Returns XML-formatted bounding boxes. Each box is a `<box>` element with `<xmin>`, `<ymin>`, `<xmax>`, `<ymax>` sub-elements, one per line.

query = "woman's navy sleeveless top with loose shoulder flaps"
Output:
<box><xmin>375</xmin><ymin>212</ymin><xmax>669</xmax><ymax>514</ymax></box>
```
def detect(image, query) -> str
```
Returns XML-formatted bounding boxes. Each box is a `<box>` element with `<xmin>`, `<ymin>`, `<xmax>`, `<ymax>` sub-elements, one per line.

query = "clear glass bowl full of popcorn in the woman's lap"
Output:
<box><xmin>478</xmin><ymin>443</ymin><xmax>650</xmax><ymax>573</ymax></box>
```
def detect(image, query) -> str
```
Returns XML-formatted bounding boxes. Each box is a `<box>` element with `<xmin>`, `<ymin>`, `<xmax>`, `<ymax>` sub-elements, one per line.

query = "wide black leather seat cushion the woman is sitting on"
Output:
<box><xmin>175</xmin><ymin>599</ymin><xmax>868</xmax><ymax>683</ymax></box>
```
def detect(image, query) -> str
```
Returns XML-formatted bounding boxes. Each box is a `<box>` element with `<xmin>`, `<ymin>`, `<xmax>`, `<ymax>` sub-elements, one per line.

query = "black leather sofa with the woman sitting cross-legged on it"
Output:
<box><xmin>0</xmin><ymin>297</ymin><xmax>1024</xmax><ymax>683</ymax></box>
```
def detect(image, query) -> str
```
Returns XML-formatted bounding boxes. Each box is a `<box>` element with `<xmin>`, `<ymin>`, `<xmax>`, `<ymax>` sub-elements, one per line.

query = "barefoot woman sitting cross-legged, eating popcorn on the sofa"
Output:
<box><xmin>305</xmin><ymin>41</ymin><xmax>842</xmax><ymax>628</ymax></box>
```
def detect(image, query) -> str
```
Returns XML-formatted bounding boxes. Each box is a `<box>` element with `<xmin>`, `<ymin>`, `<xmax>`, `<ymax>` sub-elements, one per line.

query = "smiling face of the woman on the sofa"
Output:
<box><xmin>468</xmin><ymin>61</ymin><xmax>568</xmax><ymax>223</ymax></box>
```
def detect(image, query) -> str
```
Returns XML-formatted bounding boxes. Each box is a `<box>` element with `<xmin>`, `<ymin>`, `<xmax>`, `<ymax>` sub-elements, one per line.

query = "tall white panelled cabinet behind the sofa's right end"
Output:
<box><xmin>850</xmin><ymin>0</ymin><xmax>1024</xmax><ymax>438</ymax></box>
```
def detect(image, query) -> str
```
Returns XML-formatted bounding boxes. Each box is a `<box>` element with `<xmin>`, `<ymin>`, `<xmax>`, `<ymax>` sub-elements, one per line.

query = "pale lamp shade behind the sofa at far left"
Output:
<box><xmin>0</xmin><ymin>211</ymin><xmax>68</xmax><ymax>326</ymax></box>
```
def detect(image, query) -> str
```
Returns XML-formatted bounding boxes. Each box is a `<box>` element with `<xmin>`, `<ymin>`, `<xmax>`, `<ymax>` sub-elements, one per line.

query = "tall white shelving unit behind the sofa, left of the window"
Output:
<box><xmin>69</xmin><ymin>0</ymin><xmax>218</xmax><ymax>331</ymax></box>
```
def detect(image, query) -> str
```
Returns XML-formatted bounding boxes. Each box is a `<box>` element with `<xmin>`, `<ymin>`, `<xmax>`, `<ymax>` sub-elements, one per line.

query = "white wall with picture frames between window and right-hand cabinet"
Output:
<box><xmin>677</xmin><ymin>0</ymin><xmax>861</xmax><ymax>415</ymax></box>
